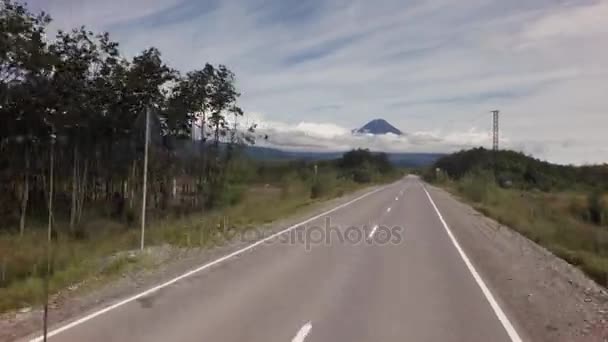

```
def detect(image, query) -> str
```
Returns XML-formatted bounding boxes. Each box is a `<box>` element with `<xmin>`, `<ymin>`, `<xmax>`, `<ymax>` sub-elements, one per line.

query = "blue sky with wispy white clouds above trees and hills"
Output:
<box><xmin>29</xmin><ymin>0</ymin><xmax>608</xmax><ymax>164</ymax></box>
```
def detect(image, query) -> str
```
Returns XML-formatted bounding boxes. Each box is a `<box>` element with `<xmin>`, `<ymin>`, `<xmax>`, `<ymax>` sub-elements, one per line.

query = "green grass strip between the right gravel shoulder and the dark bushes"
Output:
<box><xmin>439</xmin><ymin>175</ymin><xmax>608</xmax><ymax>287</ymax></box>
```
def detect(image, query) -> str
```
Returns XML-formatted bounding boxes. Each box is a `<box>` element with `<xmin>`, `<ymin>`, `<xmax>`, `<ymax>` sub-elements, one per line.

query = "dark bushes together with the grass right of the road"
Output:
<box><xmin>424</xmin><ymin>149</ymin><xmax>608</xmax><ymax>286</ymax></box>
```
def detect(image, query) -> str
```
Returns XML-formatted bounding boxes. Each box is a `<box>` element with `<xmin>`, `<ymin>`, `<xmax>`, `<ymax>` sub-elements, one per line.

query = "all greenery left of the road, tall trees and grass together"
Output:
<box><xmin>0</xmin><ymin>0</ymin><xmax>398</xmax><ymax>311</ymax></box>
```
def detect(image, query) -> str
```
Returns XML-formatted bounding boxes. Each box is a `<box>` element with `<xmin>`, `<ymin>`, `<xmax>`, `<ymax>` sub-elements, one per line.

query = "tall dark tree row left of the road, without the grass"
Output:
<box><xmin>0</xmin><ymin>0</ymin><xmax>255</xmax><ymax>234</ymax></box>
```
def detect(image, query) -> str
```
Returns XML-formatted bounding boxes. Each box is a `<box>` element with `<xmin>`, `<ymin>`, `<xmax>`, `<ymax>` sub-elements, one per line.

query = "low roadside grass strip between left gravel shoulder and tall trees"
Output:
<box><xmin>0</xmin><ymin>175</ymin><xmax>390</xmax><ymax>313</ymax></box>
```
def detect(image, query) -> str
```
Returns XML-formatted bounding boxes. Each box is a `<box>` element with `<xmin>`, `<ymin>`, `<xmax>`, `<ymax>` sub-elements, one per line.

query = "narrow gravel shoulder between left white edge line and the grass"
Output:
<box><xmin>0</xmin><ymin>186</ymin><xmax>380</xmax><ymax>341</ymax></box>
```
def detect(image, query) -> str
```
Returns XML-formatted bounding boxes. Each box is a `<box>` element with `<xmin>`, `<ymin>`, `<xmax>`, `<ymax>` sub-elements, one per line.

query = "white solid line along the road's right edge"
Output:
<box><xmin>422</xmin><ymin>186</ymin><xmax>522</xmax><ymax>342</ymax></box>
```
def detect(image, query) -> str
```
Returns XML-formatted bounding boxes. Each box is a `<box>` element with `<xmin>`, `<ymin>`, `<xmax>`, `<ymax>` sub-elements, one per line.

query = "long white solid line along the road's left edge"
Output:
<box><xmin>30</xmin><ymin>184</ymin><xmax>392</xmax><ymax>342</ymax></box>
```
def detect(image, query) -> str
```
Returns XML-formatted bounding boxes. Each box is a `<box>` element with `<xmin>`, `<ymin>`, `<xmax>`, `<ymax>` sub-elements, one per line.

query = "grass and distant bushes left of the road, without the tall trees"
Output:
<box><xmin>0</xmin><ymin>146</ymin><xmax>402</xmax><ymax>312</ymax></box>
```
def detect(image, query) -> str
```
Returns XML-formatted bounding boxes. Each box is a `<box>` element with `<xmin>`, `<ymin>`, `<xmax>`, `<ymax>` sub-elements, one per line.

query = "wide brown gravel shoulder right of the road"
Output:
<box><xmin>426</xmin><ymin>185</ymin><xmax>608</xmax><ymax>342</ymax></box>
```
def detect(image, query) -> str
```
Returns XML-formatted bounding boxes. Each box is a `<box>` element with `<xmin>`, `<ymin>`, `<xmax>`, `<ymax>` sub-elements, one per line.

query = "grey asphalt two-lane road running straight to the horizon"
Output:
<box><xmin>27</xmin><ymin>176</ymin><xmax>520</xmax><ymax>342</ymax></box>
